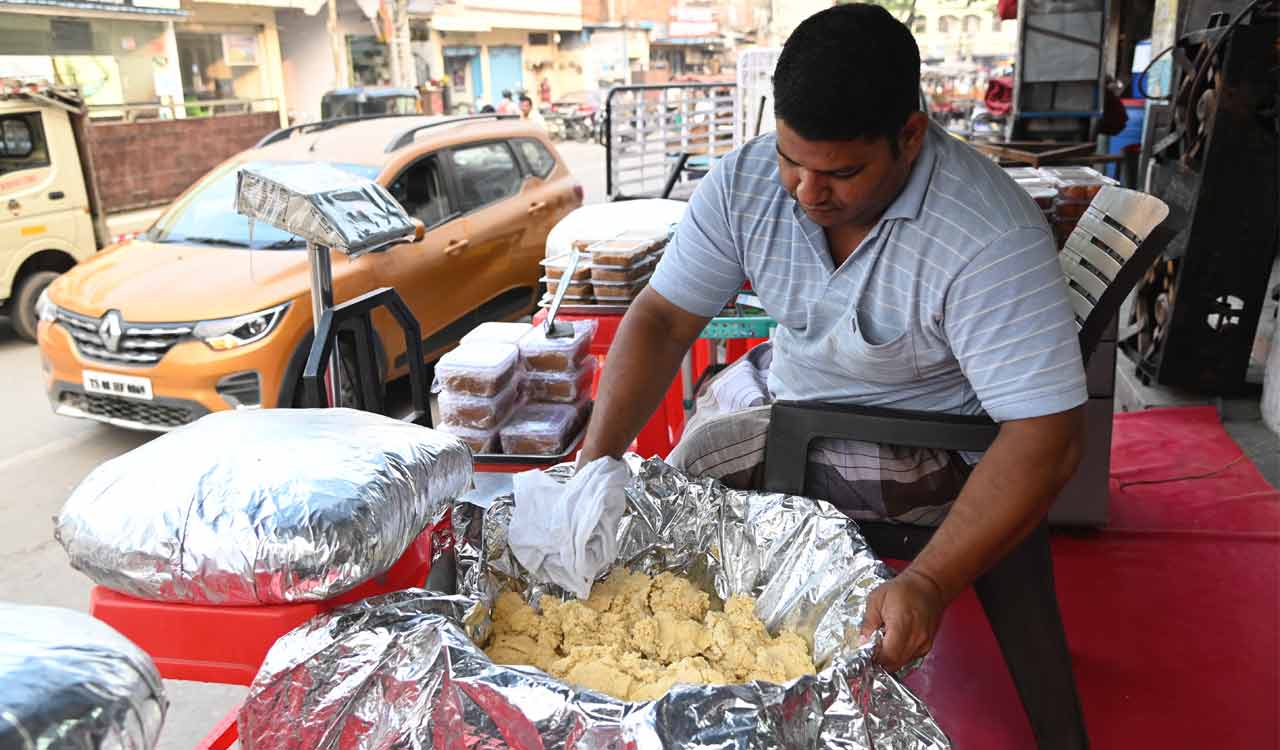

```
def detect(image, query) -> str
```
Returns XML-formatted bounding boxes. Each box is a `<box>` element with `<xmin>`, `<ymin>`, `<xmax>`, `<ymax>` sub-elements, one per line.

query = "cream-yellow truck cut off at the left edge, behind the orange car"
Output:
<box><xmin>0</xmin><ymin>79</ymin><xmax>109</xmax><ymax>340</ymax></box>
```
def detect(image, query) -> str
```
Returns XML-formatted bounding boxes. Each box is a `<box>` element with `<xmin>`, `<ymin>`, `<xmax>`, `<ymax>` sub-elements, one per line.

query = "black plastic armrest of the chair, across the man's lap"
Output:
<box><xmin>764</xmin><ymin>401</ymin><xmax>1000</xmax><ymax>494</ymax></box>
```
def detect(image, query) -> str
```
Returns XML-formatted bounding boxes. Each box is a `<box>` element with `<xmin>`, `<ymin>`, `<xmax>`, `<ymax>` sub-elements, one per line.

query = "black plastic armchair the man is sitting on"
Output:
<box><xmin>764</xmin><ymin>187</ymin><xmax>1181</xmax><ymax>749</ymax></box>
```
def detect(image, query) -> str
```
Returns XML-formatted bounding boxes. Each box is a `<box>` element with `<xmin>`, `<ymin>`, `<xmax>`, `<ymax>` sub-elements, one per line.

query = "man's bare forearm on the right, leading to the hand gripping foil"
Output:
<box><xmin>908</xmin><ymin>407</ymin><xmax>1084</xmax><ymax>602</ymax></box>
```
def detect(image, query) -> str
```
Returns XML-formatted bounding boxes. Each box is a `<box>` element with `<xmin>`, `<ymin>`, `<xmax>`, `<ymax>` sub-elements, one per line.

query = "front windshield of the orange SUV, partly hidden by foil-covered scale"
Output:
<box><xmin>147</xmin><ymin>161</ymin><xmax>379</xmax><ymax>250</ymax></box>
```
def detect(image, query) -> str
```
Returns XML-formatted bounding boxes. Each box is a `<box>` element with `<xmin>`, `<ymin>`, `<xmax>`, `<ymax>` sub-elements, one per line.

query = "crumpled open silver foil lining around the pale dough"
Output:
<box><xmin>239</xmin><ymin>459</ymin><xmax>950</xmax><ymax>750</ymax></box>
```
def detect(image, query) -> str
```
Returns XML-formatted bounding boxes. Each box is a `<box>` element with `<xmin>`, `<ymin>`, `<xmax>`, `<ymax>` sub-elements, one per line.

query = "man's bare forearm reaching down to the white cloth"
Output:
<box><xmin>579</xmin><ymin>289</ymin><xmax>708</xmax><ymax>465</ymax></box>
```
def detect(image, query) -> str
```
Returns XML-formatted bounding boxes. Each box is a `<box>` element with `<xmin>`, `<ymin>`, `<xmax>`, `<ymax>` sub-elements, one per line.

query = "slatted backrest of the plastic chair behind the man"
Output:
<box><xmin>1059</xmin><ymin>186</ymin><xmax>1181</xmax><ymax>361</ymax></box>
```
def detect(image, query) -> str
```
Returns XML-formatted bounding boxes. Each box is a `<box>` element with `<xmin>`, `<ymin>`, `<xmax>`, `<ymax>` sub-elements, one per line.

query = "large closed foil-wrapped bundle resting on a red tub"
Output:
<box><xmin>55</xmin><ymin>410</ymin><xmax>471</xmax><ymax>605</ymax></box>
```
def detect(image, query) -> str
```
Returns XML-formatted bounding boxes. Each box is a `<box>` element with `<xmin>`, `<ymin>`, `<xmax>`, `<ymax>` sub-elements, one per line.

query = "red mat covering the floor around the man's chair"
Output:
<box><xmin>908</xmin><ymin>408</ymin><xmax>1280</xmax><ymax>750</ymax></box>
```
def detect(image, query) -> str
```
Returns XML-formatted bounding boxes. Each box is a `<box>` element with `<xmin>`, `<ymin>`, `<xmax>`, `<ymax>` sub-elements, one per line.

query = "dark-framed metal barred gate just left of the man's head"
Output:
<box><xmin>604</xmin><ymin>83</ymin><xmax>736</xmax><ymax>201</ymax></box>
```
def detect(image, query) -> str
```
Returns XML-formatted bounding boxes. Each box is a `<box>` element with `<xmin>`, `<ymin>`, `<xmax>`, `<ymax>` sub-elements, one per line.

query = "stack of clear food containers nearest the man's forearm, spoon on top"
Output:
<box><xmin>499</xmin><ymin>320</ymin><xmax>596</xmax><ymax>456</ymax></box>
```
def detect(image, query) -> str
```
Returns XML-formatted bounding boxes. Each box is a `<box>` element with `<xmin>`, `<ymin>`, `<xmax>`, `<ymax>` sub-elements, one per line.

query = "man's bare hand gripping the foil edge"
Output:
<box><xmin>861</xmin><ymin>568</ymin><xmax>947</xmax><ymax>672</ymax></box>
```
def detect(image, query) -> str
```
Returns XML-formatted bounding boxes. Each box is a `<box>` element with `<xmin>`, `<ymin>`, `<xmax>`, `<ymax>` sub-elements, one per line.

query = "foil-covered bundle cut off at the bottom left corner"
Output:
<box><xmin>0</xmin><ymin>603</ymin><xmax>169</xmax><ymax>750</ymax></box>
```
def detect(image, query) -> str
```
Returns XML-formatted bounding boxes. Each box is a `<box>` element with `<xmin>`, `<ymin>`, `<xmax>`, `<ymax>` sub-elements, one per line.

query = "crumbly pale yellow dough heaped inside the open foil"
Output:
<box><xmin>485</xmin><ymin>568</ymin><xmax>814</xmax><ymax>700</ymax></box>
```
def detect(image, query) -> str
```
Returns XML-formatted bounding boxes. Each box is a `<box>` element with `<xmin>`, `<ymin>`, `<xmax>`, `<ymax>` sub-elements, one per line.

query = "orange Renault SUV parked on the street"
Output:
<box><xmin>37</xmin><ymin>116</ymin><xmax>582</xmax><ymax>431</ymax></box>
